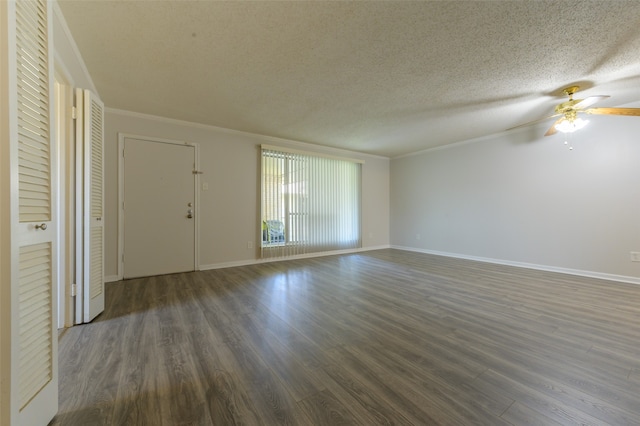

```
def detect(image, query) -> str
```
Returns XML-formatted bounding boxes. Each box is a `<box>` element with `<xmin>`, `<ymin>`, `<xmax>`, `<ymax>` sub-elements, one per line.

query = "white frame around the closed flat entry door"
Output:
<box><xmin>117</xmin><ymin>133</ymin><xmax>202</xmax><ymax>280</ymax></box>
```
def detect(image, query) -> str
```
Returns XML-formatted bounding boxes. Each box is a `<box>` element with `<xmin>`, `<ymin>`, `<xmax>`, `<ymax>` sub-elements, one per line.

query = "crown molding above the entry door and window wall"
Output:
<box><xmin>105</xmin><ymin>108</ymin><xmax>389</xmax><ymax>160</ymax></box>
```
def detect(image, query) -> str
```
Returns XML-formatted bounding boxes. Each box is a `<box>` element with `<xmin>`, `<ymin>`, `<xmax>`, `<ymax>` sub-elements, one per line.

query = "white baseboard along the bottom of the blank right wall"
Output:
<box><xmin>391</xmin><ymin>245</ymin><xmax>640</xmax><ymax>285</ymax></box>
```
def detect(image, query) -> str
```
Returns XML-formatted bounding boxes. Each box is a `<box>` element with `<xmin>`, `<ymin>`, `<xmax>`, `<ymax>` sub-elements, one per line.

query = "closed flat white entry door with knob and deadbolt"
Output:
<box><xmin>122</xmin><ymin>137</ymin><xmax>196</xmax><ymax>278</ymax></box>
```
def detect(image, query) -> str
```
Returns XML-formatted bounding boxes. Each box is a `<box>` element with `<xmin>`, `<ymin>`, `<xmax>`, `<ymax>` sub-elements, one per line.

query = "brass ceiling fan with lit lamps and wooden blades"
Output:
<box><xmin>507</xmin><ymin>86</ymin><xmax>640</xmax><ymax>136</ymax></box>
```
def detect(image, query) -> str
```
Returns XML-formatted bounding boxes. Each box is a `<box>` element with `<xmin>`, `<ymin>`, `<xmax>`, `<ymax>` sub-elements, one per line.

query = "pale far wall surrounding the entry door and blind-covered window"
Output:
<box><xmin>105</xmin><ymin>109</ymin><xmax>390</xmax><ymax>279</ymax></box>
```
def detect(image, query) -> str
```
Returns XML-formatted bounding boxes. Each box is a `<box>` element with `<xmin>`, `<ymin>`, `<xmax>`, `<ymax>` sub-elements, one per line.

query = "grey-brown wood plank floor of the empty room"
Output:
<box><xmin>52</xmin><ymin>250</ymin><xmax>640</xmax><ymax>426</ymax></box>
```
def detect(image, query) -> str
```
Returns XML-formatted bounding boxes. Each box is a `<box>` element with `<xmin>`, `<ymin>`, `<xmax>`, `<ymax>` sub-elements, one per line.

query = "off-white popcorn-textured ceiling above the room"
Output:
<box><xmin>58</xmin><ymin>0</ymin><xmax>640</xmax><ymax>157</ymax></box>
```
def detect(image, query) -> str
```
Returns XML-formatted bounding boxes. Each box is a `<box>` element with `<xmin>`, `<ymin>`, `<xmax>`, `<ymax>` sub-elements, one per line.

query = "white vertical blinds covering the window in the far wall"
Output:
<box><xmin>261</xmin><ymin>146</ymin><xmax>361</xmax><ymax>257</ymax></box>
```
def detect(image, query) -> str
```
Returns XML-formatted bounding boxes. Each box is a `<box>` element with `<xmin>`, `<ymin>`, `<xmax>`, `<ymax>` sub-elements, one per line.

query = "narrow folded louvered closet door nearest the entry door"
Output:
<box><xmin>76</xmin><ymin>89</ymin><xmax>104</xmax><ymax>322</ymax></box>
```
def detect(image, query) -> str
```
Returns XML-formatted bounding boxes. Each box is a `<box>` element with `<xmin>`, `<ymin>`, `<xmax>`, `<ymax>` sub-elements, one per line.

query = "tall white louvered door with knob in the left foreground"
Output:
<box><xmin>8</xmin><ymin>0</ymin><xmax>58</xmax><ymax>426</ymax></box>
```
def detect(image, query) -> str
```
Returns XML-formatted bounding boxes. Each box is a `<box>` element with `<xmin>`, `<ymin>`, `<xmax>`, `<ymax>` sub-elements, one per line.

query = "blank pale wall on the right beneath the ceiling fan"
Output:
<box><xmin>391</xmin><ymin>116</ymin><xmax>640</xmax><ymax>283</ymax></box>
